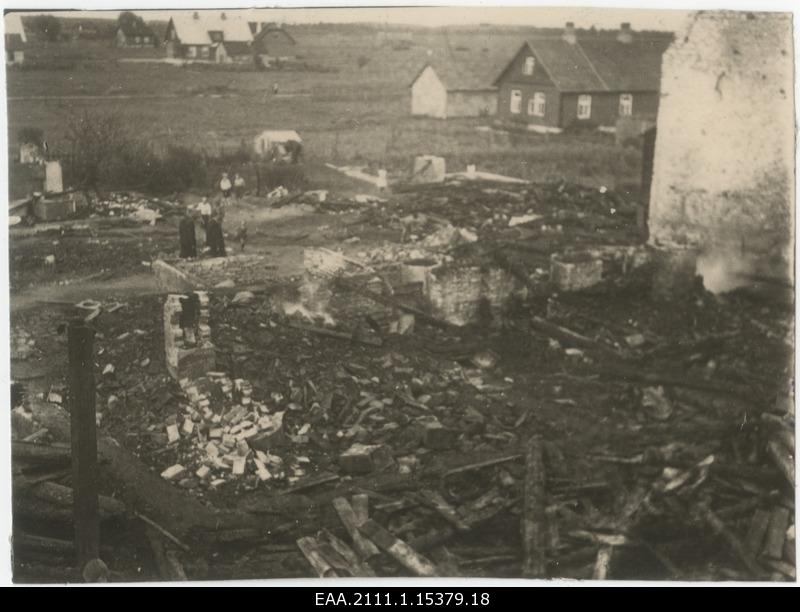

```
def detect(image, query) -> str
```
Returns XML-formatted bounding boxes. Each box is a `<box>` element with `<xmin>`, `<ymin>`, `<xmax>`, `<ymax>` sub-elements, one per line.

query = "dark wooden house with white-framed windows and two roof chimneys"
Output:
<box><xmin>494</xmin><ymin>23</ymin><xmax>671</xmax><ymax>131</ymax></box>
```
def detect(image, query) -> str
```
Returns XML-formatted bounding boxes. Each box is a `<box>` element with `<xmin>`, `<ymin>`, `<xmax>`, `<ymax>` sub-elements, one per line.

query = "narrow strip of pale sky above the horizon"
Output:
<box><xmin>6</xmin><ymin>0</ymin><xmax>704</xmax><ymax>31</ymax></box>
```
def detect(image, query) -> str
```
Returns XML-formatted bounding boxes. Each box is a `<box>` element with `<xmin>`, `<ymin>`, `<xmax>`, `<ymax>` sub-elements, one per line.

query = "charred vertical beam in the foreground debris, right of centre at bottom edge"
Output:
<box><xmin>522</xmin><ymin>436</ymin><xmax>547</xmax><ymax>578</ymax></box>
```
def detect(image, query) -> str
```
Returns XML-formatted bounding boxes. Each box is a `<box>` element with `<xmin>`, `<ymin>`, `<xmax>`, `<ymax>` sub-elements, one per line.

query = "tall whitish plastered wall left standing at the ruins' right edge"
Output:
<box><xmin>650</xmin><ymin>12</ymin><xmax>794</xmax><ymax>274</ymax></box>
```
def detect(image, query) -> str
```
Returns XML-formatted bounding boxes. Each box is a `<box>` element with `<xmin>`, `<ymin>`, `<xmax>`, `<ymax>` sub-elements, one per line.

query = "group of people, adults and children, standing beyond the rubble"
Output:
<box><xmin>178</xmin><ymin>172</ymin><xmax>252</xmax><ymax>259</ymax></box>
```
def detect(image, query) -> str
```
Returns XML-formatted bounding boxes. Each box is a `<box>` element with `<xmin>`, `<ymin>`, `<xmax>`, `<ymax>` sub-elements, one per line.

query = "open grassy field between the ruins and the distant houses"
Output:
<box><xmin>8</xmin><ymin>25</ymin><xmax>639</xmax><ymax>187</ymax></box>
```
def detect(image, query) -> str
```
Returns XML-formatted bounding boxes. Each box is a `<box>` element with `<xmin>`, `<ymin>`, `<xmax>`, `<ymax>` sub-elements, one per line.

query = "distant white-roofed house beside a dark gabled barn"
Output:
<box><xmin>164</xmin><ymin>12</ymin><xmax>253</xmax><ymax>64</ymax></box>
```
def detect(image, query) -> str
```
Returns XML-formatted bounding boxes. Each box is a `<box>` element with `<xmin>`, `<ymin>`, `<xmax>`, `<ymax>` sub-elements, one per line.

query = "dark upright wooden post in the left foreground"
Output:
<box><xmin>67</xmin><ymin>320</ymin><xmax>100</xmax><ymax>567</ymax></box>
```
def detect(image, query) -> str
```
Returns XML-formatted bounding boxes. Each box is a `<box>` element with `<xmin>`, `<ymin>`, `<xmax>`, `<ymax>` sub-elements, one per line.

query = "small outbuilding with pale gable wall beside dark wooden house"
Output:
<box><xmin>411</xmin><ymin>62</ymin><xmax>497</xmax><ymax>119</ymax></box>
